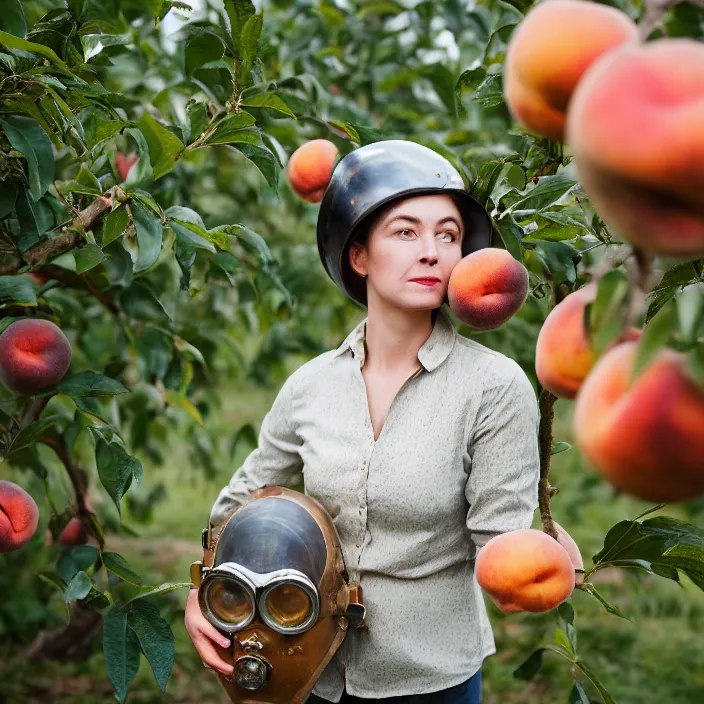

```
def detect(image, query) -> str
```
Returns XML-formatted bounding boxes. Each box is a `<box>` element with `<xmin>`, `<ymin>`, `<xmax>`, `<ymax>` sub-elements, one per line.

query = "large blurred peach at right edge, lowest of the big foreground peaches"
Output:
<box><xmin>572</xmin><ymin>342</ymin><xmax>704</xmax><ymax>503</ymax></box>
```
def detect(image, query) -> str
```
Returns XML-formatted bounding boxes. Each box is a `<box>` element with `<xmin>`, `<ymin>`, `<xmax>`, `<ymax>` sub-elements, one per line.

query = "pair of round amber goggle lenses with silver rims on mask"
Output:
<box><xmin>201</xmin><ymin>564</ymin><xmax>319</xmax><ymax>634</ymax></box>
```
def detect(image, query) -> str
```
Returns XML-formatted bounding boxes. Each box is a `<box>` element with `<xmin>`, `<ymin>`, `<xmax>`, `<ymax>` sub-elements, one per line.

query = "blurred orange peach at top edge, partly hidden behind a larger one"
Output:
<box><xmin>504</xmin><ymin>0</ymin><xmax>638</xmax><ymax>142</ymax></box>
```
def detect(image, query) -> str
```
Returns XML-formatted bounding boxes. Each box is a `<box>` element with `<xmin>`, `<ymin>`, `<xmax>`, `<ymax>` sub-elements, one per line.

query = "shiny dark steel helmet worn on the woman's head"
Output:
<box><xmin>317</xmin><ymin>139</ymin><xmax>492</xmax><ymax>306</ymax></box>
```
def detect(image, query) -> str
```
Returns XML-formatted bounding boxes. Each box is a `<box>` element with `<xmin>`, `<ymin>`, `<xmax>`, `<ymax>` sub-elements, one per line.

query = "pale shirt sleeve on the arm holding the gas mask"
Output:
<box><xmin>210</xmin><ymin>372</ymin><xmax>303</xmax><ymax>526</ymax></box>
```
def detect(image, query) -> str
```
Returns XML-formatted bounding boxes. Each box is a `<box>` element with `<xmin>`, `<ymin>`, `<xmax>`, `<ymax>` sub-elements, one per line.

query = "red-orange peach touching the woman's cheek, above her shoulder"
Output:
<box><xmin>447</xmin><ymin>247</ymin><xmax>528</xmax><ymax>330</ymax></box>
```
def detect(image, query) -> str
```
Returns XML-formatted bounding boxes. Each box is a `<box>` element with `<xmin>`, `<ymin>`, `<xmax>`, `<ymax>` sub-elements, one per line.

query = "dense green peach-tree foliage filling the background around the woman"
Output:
<box><xmin>0</xmin><ymin>0</ymin><xmax>704</xmax><ymax>702</ymax></box>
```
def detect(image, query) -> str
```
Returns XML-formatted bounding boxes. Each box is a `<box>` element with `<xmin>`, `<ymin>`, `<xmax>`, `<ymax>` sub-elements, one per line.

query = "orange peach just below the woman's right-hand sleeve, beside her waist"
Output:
<box><xmin>475</xmin><ymin>528</ymin><xmax>575</xmax><ymax>614</ymax></box>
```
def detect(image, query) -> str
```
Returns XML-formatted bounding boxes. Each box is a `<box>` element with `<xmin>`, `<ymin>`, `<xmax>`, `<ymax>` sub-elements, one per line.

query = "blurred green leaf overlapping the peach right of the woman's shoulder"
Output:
<box><xmin>585</xmin><ymin>269</ymin><xmax>630</xmax><ymax>357</ymax></box>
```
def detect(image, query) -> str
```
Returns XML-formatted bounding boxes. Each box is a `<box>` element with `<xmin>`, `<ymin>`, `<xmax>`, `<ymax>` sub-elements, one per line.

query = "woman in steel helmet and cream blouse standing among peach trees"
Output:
<box><xmin>186</xmin><ymin>140</ymin><xmax>539</xmax><ymax>704</ymax></box>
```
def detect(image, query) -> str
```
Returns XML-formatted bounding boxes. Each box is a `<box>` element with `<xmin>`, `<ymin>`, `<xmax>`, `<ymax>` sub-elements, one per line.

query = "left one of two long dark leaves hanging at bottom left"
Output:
<box><xmin>103</xmin><ymin>605</ymin><xmax>141</xmax><ymax>704</ymax></box>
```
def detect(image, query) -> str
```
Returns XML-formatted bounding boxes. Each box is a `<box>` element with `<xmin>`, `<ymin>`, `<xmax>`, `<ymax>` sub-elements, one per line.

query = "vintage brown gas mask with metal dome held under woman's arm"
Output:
<box><xmin>191</xmin><ymin>486</ymin><xmax>366</xmax><ymax>704</ymax></box>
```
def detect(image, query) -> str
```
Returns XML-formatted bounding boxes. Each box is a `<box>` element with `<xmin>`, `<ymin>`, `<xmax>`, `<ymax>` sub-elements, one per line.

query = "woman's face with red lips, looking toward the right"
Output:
<box><xmin>350</xmin><ymin>194</ymin><xmax>464</xmax><ymax>310</ymax></box>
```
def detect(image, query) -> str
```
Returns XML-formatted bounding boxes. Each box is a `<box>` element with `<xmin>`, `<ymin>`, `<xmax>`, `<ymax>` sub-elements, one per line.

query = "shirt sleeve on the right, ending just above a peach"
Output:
<box><xmin>465</xmin><ymin>362</ymin><xmax>540</xmax><ymax>553</ymax></box>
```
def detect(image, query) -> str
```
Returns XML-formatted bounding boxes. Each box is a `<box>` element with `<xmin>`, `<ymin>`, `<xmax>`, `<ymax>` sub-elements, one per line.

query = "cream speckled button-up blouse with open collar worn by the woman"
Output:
<box><xmin>210</xmin><ymin>309</ymin><xmax>539</xmax><ymax>702</ymax></box>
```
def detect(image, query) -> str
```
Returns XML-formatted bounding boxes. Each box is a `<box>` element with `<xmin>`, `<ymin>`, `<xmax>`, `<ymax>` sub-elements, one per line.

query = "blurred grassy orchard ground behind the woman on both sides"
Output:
<box><xmin>0</xmin><ymin>390</ymin><xmax>704</xmax><ymax>704</ymax></box>
